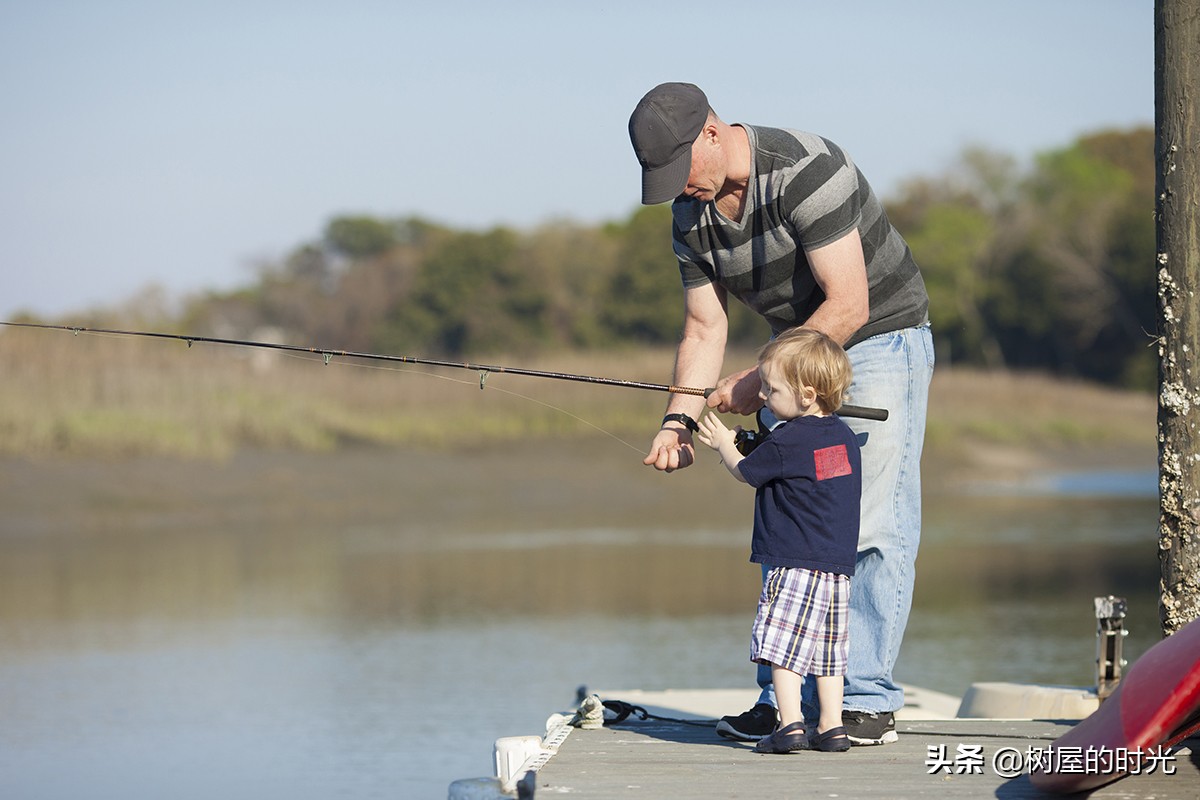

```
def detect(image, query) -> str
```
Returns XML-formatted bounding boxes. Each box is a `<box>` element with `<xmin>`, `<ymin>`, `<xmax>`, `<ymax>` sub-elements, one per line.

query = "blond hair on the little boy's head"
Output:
<box><xmin>758</xmin><ymin>327</ymin><xmax>853</xmax><ymax>414</ymax></box>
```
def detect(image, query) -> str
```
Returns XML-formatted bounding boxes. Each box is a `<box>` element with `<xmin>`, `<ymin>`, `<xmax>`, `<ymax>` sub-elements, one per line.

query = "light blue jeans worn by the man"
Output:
<box><xmin>758</xmin><ymin>325</ymin><xmax>934</xmax><ymax>720</ymax></box>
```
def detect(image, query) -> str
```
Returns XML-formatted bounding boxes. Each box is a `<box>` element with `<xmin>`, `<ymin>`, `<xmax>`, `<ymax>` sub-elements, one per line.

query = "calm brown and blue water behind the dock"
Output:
<box><xmin>0</xmin><ymin>443</ymin><xmax>1158</xmax><ymax>800</ymax></box>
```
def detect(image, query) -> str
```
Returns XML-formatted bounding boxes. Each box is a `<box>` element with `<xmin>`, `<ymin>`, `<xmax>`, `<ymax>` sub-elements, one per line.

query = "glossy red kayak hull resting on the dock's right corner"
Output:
<box><xmin>1030</xmin><ymin>620</ymin><xmax>1200</xmax><ymax>793</ymax></box>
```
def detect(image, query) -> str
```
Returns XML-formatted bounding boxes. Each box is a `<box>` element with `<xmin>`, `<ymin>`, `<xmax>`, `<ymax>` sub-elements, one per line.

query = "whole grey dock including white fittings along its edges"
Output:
<box><xmin>449</xmin><ymin>685</ymin><xmax>1200</xmax><ymax>800</ymax></box>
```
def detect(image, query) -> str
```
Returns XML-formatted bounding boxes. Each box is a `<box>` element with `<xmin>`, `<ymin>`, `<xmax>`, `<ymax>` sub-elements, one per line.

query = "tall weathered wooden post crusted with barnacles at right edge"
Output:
<box><xmin>1154</xmin><ymin>0</ymin><xmax>1200</xmax><ymax>636</ymax></box>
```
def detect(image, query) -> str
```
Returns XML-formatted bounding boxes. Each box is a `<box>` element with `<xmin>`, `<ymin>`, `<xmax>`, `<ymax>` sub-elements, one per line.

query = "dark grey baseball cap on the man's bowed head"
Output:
<box><xmin>629</xmin><ymin>83</ymin><xmax>708</xmax><ymax>205</ymax></box>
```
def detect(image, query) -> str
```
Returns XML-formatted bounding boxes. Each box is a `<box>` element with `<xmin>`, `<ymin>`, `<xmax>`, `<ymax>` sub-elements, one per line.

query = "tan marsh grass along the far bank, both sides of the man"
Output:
<box><xmin>0</xmin><ymin>329</ymin><xmax>1154</xmax><ymax>458</ymax></box>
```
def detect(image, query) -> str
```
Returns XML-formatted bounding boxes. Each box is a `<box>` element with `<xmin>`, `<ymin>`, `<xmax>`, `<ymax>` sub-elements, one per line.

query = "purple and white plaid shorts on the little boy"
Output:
<box><xmin>750</xmin><ymin>567</ymin><xmax>850</xmax><ymax>675</ymax></box>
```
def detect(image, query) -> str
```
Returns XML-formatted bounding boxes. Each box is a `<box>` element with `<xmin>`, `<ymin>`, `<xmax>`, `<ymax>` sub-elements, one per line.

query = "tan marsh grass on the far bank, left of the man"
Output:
<box><xmin>0</xmin><ymin>330</ymin><xmax>672</xmax><ymax>458</ymax></box>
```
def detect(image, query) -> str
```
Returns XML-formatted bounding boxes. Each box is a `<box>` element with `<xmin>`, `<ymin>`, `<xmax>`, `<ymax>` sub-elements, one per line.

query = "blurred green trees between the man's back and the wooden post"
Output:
<box><xmin>887</xmin><ymin>127</ymin><xmax>1157</xmax><ymax>390</ymax></box>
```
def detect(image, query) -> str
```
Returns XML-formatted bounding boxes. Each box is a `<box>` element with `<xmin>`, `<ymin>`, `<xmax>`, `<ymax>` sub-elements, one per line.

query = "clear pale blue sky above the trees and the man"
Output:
<box><xmin>0</xmin><ymin>0</ymin><xmax>1154</xmax><ymax>319</ymax></box>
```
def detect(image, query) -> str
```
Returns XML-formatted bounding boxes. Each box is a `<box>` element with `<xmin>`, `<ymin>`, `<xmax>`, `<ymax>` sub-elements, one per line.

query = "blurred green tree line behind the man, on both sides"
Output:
<box><xmin>179</xmin><ymin>127</ymin><xmax>1156</xmax><ymax>389</ymax></box>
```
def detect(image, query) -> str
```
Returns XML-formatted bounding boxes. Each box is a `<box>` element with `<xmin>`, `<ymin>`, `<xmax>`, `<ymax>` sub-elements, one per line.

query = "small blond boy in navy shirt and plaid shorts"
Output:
<box><xmin>700</xmin><ymin>327</ymin><xmax>862</xmax><ymax>753</ymax></box>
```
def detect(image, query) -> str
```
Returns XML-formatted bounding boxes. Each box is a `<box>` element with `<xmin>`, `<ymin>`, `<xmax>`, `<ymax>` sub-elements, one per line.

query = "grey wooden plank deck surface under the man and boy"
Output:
<box><xmin>535</xmin><ymin>718</ymin><xmax>1200</xmax><ymax>800</ymax></box>
